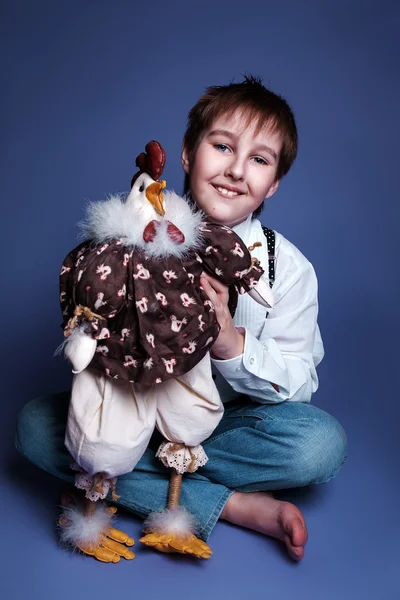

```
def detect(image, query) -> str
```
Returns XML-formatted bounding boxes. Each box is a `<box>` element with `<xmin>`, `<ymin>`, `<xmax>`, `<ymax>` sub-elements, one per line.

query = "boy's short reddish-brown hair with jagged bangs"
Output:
<box><xmin>183</xmin><ymin>75</ymin><xmax>298</xmax><ymax>217</ymax></box>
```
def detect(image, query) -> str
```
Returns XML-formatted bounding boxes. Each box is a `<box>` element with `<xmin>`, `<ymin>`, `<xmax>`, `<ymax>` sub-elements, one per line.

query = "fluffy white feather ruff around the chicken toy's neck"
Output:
<box><xmin>79</xmin><ymin>191</ymin><xmax>204</xmax><ymax>258</ymax></box>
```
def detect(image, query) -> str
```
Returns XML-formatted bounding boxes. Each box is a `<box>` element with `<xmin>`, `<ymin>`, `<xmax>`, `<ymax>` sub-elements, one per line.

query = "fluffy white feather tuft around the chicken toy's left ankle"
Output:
<box><xmin>59</xmin><ymin>502</ymin><xmax>113</xmax><ymax>547</ymax></box>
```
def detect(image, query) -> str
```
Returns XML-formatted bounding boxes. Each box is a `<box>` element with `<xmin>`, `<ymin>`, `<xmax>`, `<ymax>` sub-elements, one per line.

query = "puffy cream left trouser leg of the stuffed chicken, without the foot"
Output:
<box><xmin>65</xmin><ymin>369</ymin><xmax>157</xmax><ymax>480</ymax></box>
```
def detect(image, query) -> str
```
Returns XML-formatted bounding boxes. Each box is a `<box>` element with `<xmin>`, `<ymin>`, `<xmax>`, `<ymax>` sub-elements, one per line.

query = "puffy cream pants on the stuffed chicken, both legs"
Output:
<box><xmin>65</xmin><ymin>354</ymin><xmax>223</xmax><ymax>499</ymax></box>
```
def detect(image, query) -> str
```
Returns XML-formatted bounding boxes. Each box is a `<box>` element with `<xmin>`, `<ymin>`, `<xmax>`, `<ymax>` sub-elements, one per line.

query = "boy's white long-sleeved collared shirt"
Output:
<box><xmin>212</xmin><ymin>215</ymin><xmax>324</xmax><ymax>404</ymax></box>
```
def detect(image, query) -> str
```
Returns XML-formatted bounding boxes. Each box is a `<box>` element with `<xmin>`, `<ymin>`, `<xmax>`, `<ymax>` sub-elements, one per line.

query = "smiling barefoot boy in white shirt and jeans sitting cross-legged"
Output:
<box><xmin>17</xmin><ymin>77</ymin><xmax>346</xmax><ymax>560</ymax></box>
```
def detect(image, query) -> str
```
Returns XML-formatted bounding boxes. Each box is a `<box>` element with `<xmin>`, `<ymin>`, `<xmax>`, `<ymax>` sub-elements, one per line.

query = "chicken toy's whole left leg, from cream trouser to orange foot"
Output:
<box><xmin>60</xmin><ymin>369</ymin><xmax>156</xmax><ymax>562</ymax></box>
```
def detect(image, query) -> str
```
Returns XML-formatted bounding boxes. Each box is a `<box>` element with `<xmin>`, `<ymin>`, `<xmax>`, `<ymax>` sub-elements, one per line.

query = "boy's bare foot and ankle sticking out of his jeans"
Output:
<box><xmin>220</xmin><ymin>492</ymin><xmax>308</xmax><ymax>560</ymax></box>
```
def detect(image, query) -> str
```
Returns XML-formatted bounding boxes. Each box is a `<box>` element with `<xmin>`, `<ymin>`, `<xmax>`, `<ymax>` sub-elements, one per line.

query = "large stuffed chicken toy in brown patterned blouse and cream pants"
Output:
<box><xmin>60</xmin><ymin>141</ymin><xmax>273</xmax><ymax>562</ymax></box>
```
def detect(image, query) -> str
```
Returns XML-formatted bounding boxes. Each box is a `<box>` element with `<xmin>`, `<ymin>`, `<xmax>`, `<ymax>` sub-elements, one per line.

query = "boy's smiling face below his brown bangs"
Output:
<box><xmin>182</xmin><ymin>110</ymin><xmax>282</xmax><ymax>227</ymax></box>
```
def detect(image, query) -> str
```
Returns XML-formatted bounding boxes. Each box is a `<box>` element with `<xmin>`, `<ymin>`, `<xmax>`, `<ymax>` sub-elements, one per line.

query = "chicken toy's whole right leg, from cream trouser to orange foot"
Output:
<box><xmin>140</xmin><ymin>355</ymin><xmax>223</xmax><ymax>558</ymax></box>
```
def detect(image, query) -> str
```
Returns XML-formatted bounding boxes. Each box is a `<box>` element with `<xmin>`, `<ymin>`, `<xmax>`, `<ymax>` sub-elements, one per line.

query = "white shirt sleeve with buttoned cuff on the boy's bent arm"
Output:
<box><xmin>212</xmin><ymin>261</ymin><xmax>323</xmax><ymax>403</ymax></box>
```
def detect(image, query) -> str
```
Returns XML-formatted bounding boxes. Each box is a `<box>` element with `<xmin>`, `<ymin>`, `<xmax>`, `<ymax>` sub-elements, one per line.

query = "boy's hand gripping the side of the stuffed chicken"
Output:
<box><xmin>200</xmin><ymin>273</ymin><xmax>244</xmax><ymax>360</ymax></box>
